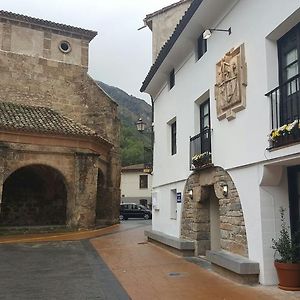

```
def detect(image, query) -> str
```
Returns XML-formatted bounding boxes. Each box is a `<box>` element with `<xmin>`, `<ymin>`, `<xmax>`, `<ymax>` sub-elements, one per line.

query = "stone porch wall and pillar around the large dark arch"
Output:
<box><xmin>0</xmin><ymin>143</ymin><xmax>99</xmax><ymax>228</ymax></box>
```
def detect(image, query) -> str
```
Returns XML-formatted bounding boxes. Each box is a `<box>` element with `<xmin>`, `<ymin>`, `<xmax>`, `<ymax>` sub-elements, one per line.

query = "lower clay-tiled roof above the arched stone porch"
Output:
<box><xmin>0</xmin><ymin>102</ymin><xmax>108</xmax><ymax>140</ymax></box>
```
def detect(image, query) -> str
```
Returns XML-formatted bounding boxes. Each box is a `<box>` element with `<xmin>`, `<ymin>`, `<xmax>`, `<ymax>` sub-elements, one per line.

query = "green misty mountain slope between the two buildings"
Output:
<box><xmin>96</xmin><ymin>81</ymin><xmax>152</xmax><ymax>166</ymax></box>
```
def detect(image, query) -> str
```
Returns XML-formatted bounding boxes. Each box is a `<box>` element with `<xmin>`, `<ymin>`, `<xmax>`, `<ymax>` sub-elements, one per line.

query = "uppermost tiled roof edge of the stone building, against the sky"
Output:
<box><xmin>0</xmin><ymin>10</ymin><xmax>97</xmax><ymax>40</ymax></box>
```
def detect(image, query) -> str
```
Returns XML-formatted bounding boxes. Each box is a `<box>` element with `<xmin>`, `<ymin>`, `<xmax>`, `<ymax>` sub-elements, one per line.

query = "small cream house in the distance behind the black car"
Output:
<box><xmin>121</xmin><ymin>164</ymin><xmax>152</xmax><ymax>206</ymax></box>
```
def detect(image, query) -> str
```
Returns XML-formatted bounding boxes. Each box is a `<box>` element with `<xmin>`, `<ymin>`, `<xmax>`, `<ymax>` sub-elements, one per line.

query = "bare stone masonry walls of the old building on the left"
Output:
<box><xmin>0</xmin><ymin>12</ymin><xmax>121</xmax><ymax>228</ymax></box>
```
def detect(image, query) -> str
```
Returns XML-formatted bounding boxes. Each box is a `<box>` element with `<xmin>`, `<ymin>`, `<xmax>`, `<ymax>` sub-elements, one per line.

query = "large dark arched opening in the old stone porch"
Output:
<box><xmin>0</xmin><ymin>165</ymin><xmax>67</xmax><ymax>226</ymax></box>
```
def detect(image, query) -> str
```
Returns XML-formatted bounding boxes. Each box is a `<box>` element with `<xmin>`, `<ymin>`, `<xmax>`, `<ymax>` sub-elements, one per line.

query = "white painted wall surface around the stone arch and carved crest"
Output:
<box><xmin>145</xmin><ymin>0</ymin><xmax>300</xmax><ymax>285</ymax></box>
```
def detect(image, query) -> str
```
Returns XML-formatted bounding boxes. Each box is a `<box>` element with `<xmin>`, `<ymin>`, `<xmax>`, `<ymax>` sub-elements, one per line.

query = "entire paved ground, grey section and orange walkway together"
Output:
<box><xmin>0</xmin><ymin>220</ymin><xmax>300</xmax><ymax>300</ymax></box>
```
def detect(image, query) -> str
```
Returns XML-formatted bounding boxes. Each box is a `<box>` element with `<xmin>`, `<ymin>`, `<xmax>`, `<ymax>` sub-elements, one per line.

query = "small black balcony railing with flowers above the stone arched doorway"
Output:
<box><xmin>190</xmin><ymin>128</ymin><xmax>212</xmax><ymax>170</ymax></box>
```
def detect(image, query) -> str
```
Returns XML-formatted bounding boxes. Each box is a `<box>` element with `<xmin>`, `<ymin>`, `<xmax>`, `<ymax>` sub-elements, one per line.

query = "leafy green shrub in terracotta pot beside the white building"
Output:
<box><xmin>272</xmin><ymin>207</ymin><xmax>300</xmax><ymax>291</ymax></box>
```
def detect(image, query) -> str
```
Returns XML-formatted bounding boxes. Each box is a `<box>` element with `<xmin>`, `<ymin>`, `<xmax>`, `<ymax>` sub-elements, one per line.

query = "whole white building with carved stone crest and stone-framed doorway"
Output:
<box><xmin>141</xmin><ymin>0</ymin><xmax>300</xmax><ymax>284</ymax></box>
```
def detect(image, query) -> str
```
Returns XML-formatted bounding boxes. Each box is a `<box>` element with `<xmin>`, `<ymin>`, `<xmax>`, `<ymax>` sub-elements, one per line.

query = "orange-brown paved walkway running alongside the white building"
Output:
<box><xmin>91</xmin><ymin>221</ymin><xmax>300</xmax><ymax>300</ymax></box>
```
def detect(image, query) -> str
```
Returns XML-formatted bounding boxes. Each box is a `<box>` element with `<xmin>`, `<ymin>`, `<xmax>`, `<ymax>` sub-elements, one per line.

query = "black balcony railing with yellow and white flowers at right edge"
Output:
<box><xmin>266</xmin><ymin>74</ymin><xmax>300</xmax><ymax>148</ymax></box>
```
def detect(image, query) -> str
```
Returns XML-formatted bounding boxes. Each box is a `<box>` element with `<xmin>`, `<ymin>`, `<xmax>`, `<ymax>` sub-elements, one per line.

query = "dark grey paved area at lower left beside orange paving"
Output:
<box><xmin>0</xmin><ymin>240</ymin><xmax>129</xmax><ymax>300</ymax></box>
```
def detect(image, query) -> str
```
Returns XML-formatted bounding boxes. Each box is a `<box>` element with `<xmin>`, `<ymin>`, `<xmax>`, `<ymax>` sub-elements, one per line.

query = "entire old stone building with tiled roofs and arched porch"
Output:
<box><xmin>0</xmin><ymin>11</ymin><xmax>120</xmax><ymax>228</ymax></box>
